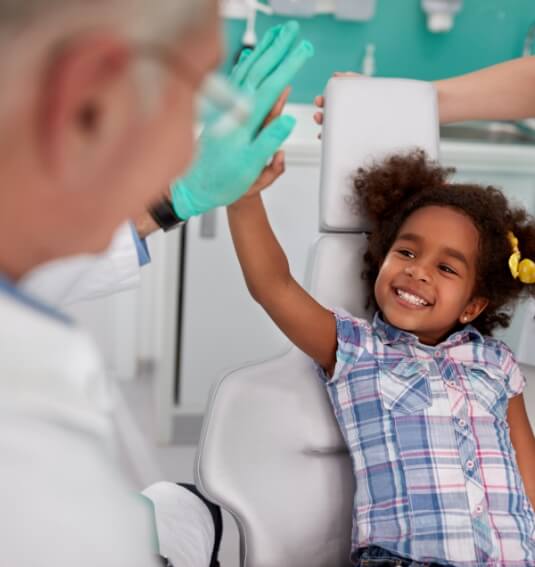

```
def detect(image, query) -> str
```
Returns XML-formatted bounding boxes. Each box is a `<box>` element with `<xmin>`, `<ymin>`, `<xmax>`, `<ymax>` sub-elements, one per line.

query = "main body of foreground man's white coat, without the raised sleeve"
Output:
<box><xmin>0</xmin><ymin>292</ymin><xmax>157</xmax><ymax>567</ymax></box>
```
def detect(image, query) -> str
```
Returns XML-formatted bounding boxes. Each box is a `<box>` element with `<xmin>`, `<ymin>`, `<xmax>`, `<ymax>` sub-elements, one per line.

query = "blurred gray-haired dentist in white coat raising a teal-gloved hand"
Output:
<box><xmin>0</xmin><ymin>0</ymin><xmax>310</xmax><ymax>567</ymax></box>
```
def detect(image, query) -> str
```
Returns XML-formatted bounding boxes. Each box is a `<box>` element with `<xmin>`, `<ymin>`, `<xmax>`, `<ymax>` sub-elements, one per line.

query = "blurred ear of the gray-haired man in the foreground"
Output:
<box><xmin>37</xmin><ymin>36</ymin><xmax>137</xmax><ymax>188</ymax></box>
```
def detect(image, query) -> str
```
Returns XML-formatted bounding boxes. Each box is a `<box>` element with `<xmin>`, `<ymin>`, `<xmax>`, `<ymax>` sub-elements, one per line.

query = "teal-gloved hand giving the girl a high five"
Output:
<box><xmin>171</xmin><ymin>22</ymin><xmax>314</xmax><ymax>220</ymax></box>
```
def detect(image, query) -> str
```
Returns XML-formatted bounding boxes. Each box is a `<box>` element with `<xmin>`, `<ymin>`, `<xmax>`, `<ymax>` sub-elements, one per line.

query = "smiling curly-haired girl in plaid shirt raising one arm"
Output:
<box><xmin>228</xmin><ymin>152</ymin><xmax>535</xmax><ymax>567</ymax></box>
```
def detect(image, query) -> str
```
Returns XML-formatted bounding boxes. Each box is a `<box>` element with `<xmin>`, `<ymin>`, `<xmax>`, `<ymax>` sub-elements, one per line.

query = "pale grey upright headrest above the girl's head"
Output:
<box><xmin>320</xmin><ymin>76</ymin><xmax>439</xmax><ymax>232</ymax></box>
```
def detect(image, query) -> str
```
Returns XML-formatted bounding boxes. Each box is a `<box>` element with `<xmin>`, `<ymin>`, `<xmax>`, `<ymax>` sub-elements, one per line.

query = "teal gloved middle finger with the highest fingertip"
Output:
<box><xmin>243</xmin><ymin>21</ymin><xmax>299</xmax><ymax>92</ymax></box>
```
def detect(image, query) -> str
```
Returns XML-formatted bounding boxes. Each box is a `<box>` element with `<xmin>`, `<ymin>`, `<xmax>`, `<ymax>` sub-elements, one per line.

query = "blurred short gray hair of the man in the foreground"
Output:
<box><xmin>0</xmin><ymin>0</ymin><xmax>215</xmax><ymax>117</ymax></box>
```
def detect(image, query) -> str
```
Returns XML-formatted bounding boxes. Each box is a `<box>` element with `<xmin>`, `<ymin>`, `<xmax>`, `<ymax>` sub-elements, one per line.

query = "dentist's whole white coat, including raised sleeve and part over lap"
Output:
<box><xmin>0</xmin><ymin>224</ymin><xmax>214</xmax><ymax>567</ymax></box>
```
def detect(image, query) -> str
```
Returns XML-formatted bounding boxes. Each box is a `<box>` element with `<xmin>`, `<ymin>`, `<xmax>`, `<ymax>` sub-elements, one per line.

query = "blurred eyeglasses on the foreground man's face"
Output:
<box><xmin>136</xmin><ymin>43</ymin><xmax>252</xmax><ymax>137</ymax></box>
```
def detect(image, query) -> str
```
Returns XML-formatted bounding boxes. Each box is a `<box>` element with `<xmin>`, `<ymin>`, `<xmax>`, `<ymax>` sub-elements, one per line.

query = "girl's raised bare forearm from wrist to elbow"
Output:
<box><xmin>227</xmin><ymin>195</ymin><xmax>292</xmax><ymax>306</ymax></box>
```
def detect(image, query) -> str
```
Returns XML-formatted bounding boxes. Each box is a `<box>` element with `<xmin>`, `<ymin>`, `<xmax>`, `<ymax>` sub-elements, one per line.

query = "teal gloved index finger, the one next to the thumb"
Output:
<box><xmin>248</xmin><ymin>41</ymin><xmax>314</xmax><ymax>132</ymax></box>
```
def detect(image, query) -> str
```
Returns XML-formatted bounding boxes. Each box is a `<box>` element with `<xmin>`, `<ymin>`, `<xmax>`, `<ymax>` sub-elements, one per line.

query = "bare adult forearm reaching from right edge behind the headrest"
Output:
<box><xmin>434</xmin><ymin>57</ymin><xmax>535</xmax><ymax>124</ymax></box>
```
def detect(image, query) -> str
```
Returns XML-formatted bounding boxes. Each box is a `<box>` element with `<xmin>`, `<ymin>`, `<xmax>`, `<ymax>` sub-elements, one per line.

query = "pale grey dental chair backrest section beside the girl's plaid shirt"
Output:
<box><xmin>196</xmin><ymin>349</ymin><xmax>353</xmax><ymax>567</ymax></box>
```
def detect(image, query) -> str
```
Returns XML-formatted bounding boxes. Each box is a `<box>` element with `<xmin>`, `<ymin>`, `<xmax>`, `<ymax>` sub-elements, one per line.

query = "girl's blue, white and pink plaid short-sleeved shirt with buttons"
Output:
<box><xmin>320</xmin><ymin>311</ymin><xmax>535</xmax><ymax>567</ymax></box>
